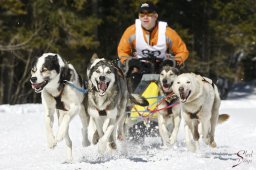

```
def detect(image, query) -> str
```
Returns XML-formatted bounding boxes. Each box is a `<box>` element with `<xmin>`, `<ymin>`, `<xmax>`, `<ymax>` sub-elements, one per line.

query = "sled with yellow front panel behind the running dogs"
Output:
<box><xmin>127</xmin><ymin>54</ymin><xmax>178</xmax><ymax>141</ymax></box>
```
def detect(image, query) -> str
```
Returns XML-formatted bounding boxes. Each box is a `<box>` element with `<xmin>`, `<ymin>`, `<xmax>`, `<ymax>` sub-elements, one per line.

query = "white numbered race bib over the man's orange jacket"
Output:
<box><xmin>135</xmin><ymin>19</ymin><xmax>167</xmax><ymax>59</ymax></box>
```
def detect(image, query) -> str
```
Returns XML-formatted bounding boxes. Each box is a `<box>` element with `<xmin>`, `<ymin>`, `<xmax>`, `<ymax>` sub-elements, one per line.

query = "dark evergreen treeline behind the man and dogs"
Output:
<box><xmin>0</xmin><ymin>0</ymin><xmax>256</xmax><ymax>104</ymax></box>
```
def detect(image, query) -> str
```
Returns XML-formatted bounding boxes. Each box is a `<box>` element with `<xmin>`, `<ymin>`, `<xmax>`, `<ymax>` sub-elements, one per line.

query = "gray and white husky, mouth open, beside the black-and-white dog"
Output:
<box><xmin>87</xmin><ymin>54</ymin><xmax>148</xmax><ymax>153</ymax></box>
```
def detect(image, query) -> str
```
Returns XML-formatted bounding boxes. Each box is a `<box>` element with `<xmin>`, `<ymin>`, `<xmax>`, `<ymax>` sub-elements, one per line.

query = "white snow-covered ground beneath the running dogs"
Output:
<box><xmin>0</xmin><ymin>86</ymin><xmax>256</xmax><ymax>170</ymax></box>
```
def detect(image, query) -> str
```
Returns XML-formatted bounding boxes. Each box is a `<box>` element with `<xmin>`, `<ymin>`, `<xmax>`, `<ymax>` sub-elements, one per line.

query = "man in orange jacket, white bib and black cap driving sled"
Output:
<box><xmin>118</xmin><ymin>2</ymin><xmax>189</xmax><ymax>90</ymax></box>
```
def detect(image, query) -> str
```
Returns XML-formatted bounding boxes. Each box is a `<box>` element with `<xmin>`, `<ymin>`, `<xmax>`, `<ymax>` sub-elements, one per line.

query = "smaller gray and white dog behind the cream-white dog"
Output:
<box><xmin>158</xmin><ymin>61</ymin><xmax>181</xmax><ymax>146</ymax></box>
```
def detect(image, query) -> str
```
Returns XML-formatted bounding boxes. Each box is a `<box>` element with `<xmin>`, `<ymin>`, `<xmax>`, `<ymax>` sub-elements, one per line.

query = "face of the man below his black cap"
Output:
<box><xmin>139</xmin><ymin>11</ymin><xmax>158</xmax><ymax>30</ymax></box>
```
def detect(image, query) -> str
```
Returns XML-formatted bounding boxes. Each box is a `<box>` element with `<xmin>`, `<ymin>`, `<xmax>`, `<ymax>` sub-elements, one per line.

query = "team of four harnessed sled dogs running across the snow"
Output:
<box><xmin>30</xmin><ymin>53</ymin><xmax>229</xmax><ymax>162</ymax></box>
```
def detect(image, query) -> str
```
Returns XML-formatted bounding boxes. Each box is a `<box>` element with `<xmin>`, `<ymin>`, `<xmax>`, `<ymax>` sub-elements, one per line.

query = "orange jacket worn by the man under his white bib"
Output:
<box><xmin>117</xmin><ymin>24</ymin><xmax>189</xmax><ymax>64</ymax></box>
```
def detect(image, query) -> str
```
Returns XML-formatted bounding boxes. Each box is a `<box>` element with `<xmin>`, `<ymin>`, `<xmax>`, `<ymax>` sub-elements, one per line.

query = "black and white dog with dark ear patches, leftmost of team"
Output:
<box><xmin>30</xmin><ymin>53</ymin><xmax>89</xmax><ymax>162</ymax></box>
